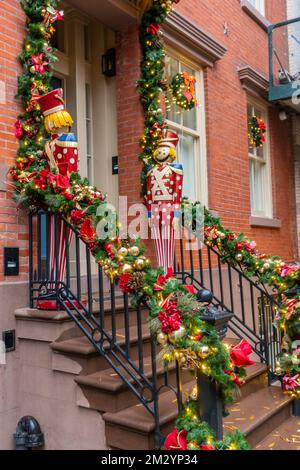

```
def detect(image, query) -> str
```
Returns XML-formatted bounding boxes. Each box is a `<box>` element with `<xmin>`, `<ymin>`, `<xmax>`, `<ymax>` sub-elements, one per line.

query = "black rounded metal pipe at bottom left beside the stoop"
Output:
<box><xmin>14</xmin><ymin>416</ymin><xmax>44</xmax><ymax>450</ymax></box>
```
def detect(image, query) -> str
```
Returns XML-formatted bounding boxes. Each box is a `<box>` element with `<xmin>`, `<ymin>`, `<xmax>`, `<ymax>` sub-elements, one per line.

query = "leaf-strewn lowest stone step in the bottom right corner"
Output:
<box><xmin>253</xmin><ymin>416</ymin><xmax>300</xmax><ymax>450</ymax></box>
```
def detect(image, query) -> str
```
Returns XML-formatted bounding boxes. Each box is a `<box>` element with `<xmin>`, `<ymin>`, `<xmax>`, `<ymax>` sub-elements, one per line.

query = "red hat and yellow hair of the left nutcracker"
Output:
<box><xmin>37</xmin><ymin>88</ymin><xmax>73</xmax><ymax>134</ymax></box>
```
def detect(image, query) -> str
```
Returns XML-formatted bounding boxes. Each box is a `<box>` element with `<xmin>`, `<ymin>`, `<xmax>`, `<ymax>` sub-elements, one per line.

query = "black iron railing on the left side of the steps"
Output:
<box><xmin>29</xmin><ymin>211</ymin><xmax>182</xmax><ymax>448</ymax></box>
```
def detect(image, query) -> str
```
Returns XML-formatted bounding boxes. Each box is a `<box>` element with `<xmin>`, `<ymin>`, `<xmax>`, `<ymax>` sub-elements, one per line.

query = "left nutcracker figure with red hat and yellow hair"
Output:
<box><xmin>37</xmin><ymin>89</ymin><xmax>78</xmax><ymax>310</ymax></box>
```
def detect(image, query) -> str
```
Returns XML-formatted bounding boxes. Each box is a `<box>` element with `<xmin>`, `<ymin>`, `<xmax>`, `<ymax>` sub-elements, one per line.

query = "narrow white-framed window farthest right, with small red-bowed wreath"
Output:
<box><xmin>248</xmin><ymin>102</ymin><xmax>272</xmax><ymax>218</ymax></box>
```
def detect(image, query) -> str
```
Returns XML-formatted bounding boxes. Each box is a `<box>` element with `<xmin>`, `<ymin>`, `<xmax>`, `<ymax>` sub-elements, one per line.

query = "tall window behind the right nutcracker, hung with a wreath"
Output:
<box><xmin>166</xmin><ymin>55</ymin><xmax>208</xmax><ymax>205</ymax></box>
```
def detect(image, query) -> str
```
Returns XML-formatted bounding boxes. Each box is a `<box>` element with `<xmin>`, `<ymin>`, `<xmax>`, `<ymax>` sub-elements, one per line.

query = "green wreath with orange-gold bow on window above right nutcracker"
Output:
<box><xmin>171</xmin><ymin>72</ymin><xmax>197</xmax><ymax>110</ymax></box>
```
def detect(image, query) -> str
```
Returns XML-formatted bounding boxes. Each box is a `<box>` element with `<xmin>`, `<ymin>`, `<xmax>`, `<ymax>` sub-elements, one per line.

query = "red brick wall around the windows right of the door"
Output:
<box><xmin>118</xmin><ymin>0</ymin><xmax>296</xmax><ymax>260</ymax></box>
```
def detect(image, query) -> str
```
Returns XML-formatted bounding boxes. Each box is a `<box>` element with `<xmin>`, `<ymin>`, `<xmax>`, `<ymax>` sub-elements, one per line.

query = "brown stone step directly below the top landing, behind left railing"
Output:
<box><xmin>51</xmin><ymin>324</ymin><xmax>151</xmax><ymax>375</ymax></box>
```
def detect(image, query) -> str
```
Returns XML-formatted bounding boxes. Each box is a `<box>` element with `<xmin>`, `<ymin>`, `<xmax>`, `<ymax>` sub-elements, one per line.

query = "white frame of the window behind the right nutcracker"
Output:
<box><xmin>166</xmin><ymin>47</ymin><xmax>208</xmax><ymax>207</ymax></box>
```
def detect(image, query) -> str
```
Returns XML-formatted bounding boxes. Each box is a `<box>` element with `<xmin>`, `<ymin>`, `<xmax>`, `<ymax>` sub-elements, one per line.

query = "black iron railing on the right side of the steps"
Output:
<box><xmin>174</xmin><ymin>232</ymin><xmax>281</xmax><ymax>381</ymax></box>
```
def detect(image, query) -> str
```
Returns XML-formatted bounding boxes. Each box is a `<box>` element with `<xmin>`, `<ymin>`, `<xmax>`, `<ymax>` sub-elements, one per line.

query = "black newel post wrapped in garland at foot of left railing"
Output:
<box><xmin>197</xmin><ymin>305</ymin><xmax>233</xmax><ymax>440</ymax></box>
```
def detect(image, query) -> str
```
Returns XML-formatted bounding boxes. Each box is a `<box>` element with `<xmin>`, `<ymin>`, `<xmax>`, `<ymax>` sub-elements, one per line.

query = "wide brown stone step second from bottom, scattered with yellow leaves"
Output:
<box><xmin>103</xmin><ymin>382</ymin><xmax>292</xmax><ymax>450</ymax></box>
